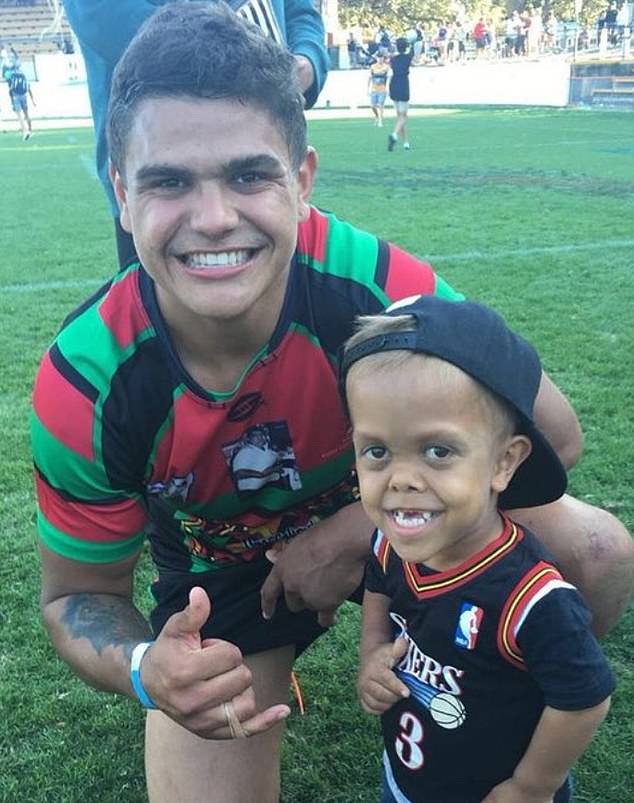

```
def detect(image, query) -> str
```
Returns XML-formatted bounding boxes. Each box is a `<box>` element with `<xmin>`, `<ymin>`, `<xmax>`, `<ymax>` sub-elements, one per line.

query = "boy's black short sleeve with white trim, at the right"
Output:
<box><xmin>516</xmin><ymin>579</ymin><xmax>616</xmax><ymax>711</ymax></box>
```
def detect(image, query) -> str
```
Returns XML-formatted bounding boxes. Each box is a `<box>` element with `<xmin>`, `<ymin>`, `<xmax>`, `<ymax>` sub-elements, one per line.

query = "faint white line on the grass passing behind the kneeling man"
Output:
<box><xmin>0</xmin><ymin>240</ymin><xmax>634</xmax><ymax>295</ymax></box>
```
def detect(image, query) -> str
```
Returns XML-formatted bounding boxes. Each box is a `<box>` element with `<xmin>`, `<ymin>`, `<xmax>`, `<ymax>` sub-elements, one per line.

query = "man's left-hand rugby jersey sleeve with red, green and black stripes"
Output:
<box><xmin>31</xmin><ymin>268</ymin><xmax>154</xmax><ymax>563</ymax></box>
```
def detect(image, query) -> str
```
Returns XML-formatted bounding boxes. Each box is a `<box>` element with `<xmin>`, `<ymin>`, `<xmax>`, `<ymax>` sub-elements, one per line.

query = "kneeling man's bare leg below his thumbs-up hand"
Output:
<box><xmin>145</xmin><ymin>647</ymin><xmax>294</xmax><ymax>803</ymax></box>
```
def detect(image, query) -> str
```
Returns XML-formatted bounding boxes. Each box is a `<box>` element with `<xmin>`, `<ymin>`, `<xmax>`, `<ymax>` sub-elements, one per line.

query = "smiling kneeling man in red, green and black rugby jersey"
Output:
<box><xmin>33</xmin><ymin>2</ymin><xmax>630</xmax><ymax>803</ymax></box>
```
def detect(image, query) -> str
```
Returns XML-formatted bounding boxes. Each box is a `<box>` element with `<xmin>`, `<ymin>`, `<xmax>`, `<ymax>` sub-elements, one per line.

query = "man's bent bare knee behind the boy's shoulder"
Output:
<box><xmin>511</xmin><ymin>495</ymin><xmax>634</xmax><ymax>636</ymax></box>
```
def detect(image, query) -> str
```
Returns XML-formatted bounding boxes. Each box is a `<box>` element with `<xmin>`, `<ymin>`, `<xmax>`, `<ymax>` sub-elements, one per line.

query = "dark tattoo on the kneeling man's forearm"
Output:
<box><xmin>62</xmin><ymin>594</ymin><xmax>150</xmax><ymax>658</ymax></box>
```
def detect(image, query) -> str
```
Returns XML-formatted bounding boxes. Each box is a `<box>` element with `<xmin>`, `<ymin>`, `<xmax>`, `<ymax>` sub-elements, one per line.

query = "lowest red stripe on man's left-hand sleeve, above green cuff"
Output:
<box><xmin>35</xmin><ymin>472</ymin><xmax>147</xmax><ymax>543</ymax></box>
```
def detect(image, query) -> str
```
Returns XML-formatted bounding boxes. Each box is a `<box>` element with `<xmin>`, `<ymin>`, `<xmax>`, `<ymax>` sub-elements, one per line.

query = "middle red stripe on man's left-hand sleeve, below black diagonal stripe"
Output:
<box><xmin>33</xmin><ymin>353</ymin><xmax>95</xmax><ymax>460</ymax></box>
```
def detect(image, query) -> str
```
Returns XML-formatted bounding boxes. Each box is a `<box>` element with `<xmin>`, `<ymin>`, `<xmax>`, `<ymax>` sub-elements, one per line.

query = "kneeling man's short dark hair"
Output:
<box><xmin>107</xmin><ymin>2</ymin><xmax>306</xmax><ymax>173</ymax></box>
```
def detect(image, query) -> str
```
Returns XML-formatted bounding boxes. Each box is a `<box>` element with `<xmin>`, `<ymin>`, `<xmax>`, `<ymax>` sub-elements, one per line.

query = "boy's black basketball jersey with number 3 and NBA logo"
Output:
<box><xmin>366</xmin><ymin>518</ymin><xmax>614</xmax><ymax>803</ymax></box>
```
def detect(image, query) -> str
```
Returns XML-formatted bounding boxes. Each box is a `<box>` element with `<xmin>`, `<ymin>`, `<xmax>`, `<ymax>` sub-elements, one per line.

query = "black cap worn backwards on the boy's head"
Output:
<box><xmin>339</xmin><ymin>295</ymin><xmax>568</xmax><ymax>509</ymax></box>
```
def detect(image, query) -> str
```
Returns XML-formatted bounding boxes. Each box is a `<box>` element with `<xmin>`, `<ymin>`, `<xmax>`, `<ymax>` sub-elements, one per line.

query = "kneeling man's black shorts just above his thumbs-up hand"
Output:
<box><xmin>150</xmin><ymin>560</ymin><xmax>360</xmax><ymax>656</ymax></box>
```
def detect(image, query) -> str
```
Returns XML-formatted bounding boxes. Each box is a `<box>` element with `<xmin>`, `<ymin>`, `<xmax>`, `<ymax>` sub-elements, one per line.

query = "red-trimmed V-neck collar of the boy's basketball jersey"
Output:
<box><xmin>403</xmin><ymin>514</ymin><xmax>524</xmax><ymax>599</ymax></box>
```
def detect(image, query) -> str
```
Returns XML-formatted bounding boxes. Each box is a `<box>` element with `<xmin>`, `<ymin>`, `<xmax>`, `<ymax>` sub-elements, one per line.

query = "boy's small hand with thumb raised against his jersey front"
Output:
<box><xmin>357</xmin><ymin>638</ymin><xmax>409</xmax><ymax>715</ymax></box>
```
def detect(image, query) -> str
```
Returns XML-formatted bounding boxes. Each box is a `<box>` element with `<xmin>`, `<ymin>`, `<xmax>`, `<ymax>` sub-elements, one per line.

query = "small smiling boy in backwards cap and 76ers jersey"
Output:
<box><xmin>340</xmin><ymin>296</ymin><xmax>615</xmax><ymax>803</ymax></box>
